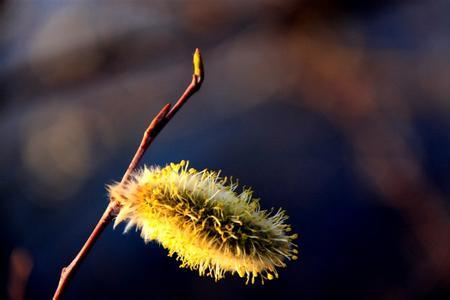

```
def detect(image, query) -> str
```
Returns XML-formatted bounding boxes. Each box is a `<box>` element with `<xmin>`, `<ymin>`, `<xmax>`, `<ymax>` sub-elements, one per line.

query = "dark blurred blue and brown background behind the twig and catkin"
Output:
<box><xmin>0</xmin><ymin>0</ymin><xmax>450</xmax><ymax>300</ymax></box>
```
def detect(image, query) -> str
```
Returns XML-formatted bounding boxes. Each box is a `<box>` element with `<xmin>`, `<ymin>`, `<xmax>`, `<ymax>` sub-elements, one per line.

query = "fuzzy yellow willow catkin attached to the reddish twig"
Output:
<box><xmin>109</xmin><ymin>161</ymin><xmax>298</xmax><ymax>283</ymax></box>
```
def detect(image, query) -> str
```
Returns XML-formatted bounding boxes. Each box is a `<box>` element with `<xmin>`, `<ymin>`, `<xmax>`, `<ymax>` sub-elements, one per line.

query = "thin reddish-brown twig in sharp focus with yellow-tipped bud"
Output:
<box><xmin>53</xmin><ymin>49</ymin><xmax>204</xmax><ymax>300</ymax></box>
